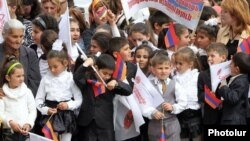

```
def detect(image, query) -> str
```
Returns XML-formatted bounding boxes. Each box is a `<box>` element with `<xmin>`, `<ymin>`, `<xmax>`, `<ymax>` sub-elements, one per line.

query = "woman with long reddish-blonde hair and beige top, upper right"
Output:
<box><xmin>217</xmin><ymin>0</ymin><xmax>250</xmax><ymax>59</ymax></box>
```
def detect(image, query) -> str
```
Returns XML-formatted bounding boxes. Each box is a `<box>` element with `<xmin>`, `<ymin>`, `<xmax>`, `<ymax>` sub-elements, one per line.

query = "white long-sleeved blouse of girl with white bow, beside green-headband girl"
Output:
<box><xmin>36</xmin><ymin>70</ymin><xmax>82</xmax><ymax>115</ymax></box>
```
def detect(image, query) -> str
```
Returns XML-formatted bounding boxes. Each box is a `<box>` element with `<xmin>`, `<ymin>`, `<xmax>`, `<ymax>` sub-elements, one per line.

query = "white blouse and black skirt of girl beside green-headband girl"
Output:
<box><xmin>36</xmin><ymin>70</ymin><xmax>82</xmax><ymax>134</ymax></box>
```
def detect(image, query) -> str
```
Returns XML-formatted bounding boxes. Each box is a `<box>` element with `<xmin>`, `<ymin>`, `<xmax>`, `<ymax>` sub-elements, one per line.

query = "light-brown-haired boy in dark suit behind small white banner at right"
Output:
<box><xmin>198</xmin><ymin>43</ymin><xmax>228</xmax><ymax>125</ymax></box>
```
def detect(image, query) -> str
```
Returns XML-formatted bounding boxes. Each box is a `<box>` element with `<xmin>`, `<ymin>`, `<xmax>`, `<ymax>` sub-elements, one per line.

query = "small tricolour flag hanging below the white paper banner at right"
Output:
<box><xmin>204</xmin><ymin>85</ymin><xmax>221</xmax><ymax>109</ymax></box>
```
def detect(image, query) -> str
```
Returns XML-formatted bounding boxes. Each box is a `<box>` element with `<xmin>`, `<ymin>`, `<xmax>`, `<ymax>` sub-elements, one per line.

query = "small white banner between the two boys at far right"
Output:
<box><xmin>210</xmin><ymin>61</ymin><xmax>231</xmax><ymax>92</ymax></box>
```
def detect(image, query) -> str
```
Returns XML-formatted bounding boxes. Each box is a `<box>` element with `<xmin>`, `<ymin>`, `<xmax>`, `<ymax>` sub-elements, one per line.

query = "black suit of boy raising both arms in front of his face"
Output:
<box><xmin>74</xmin><ymin>65</ymin><xmax>132</xmax><ymax>141</ymax></box>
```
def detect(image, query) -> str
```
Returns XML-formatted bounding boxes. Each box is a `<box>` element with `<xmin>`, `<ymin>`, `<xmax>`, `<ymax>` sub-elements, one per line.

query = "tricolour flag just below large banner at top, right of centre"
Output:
<box><xmin>164</xmin><ymin>22</ymin><xmax>179</xmax><ymax>48</ymax></box>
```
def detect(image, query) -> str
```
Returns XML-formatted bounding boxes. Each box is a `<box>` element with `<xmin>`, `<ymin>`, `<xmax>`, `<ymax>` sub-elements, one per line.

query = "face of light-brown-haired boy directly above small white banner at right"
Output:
<box><xmin>207</xmin><ymin>51</ymin><xmax>226</xmax><ymax>65</ymax></box>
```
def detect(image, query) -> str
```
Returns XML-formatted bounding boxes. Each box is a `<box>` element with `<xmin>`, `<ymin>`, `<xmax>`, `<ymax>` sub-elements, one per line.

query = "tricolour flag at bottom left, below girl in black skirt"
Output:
<box><xmin>42</xmin><ymin>121</ymin><xmax>58</xmax><ymax>141</ymax></box>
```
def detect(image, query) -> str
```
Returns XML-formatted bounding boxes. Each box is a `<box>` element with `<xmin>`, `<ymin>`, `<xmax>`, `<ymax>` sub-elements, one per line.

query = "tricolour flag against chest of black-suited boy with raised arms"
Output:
<box><xmin>87</xmin><ymin>79</ymin><xmax>106</xmax><ymax>97</ymax></box>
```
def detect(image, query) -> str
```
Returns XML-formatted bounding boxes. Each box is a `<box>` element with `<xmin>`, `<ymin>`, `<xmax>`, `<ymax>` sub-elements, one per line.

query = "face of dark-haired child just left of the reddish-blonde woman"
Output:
<box><xmin>196</xmin><ymin>32</ymin><xmax>212</xmax><ymax>49</ymax></box>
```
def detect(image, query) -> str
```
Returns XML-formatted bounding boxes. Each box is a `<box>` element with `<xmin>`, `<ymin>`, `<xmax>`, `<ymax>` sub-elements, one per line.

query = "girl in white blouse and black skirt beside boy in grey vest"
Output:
<box><xmin>170</xmin><ymin>47</ymin><xmax>201</xmax><ymax>141</ymax></box>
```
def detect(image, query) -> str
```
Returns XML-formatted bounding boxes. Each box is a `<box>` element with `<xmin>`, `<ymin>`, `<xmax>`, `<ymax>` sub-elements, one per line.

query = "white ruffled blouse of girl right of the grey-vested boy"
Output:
<box><xmin>174</xmin><ymin>69</ymin><xmax>200</xmax><ymax>110</ymax></box>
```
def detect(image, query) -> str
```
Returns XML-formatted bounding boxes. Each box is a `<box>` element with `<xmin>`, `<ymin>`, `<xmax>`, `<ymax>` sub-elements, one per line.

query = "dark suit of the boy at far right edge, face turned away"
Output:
<box><xmin>218</xmin><ymin>74</ymin><xmax>249</xmax><ymax>125</ymax></box>
